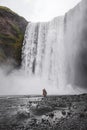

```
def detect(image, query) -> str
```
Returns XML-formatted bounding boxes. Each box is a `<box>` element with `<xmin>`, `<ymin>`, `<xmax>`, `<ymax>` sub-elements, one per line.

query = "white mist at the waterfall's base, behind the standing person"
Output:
<box><xmin>0</xmin><ymin>66</ymin><xmax>85</xmax><ymax>95</ymax></box>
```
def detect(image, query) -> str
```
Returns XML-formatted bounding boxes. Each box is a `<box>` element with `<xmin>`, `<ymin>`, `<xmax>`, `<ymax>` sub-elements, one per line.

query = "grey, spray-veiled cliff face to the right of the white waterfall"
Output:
<box><xmin>65</xmin><ymin>0</ymin><xmax>87</xmax><ymax>87</ymax></box>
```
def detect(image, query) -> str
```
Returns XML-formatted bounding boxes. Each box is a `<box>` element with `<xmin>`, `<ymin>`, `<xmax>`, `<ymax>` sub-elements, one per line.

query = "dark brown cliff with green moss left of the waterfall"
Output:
<box><xmin>0</xmin><ymin>6</ymin><xmax>27</xmax><ymax>66</ymax></box>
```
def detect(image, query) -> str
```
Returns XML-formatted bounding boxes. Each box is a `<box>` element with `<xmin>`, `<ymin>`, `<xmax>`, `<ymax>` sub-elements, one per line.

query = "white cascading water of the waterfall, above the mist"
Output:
<box><xmin>22</xmin><ymin>16</ymin><xmax>67</xmax><ymax>87</ymax></box>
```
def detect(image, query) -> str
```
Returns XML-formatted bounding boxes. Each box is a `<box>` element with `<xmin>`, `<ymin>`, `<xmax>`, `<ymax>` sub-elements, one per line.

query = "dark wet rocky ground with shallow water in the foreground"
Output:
<box><xmin>0</xmin><ymin>94</ymin><xmax>87</xmax><ymax>130</ymax></box>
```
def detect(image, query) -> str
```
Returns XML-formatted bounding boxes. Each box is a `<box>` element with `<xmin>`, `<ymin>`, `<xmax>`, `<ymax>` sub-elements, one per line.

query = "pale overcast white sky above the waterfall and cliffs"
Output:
<box><xmin>0</xmin><ymin>0</ymin><xmax>81</xmax><ymax>22</ymax></box>
